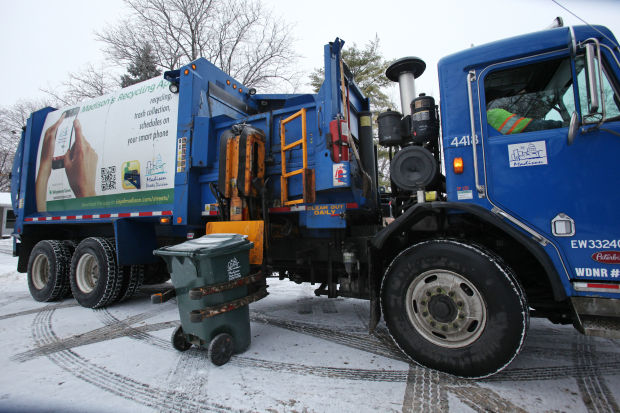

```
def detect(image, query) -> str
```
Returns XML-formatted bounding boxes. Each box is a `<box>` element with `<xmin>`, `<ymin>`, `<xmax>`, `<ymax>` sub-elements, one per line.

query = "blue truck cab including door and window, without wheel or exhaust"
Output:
<box><xmin>439</xmin><ymin>26</ymin><xmax>620</xmax><ymax>330</ymax></box>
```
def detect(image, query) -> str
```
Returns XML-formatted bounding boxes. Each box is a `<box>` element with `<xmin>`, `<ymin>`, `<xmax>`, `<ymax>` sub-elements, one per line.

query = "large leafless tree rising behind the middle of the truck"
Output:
<box><xmin>97</xmin><ymin>0</ymin><xmax>297</xmax><ymax>87</ymax></box>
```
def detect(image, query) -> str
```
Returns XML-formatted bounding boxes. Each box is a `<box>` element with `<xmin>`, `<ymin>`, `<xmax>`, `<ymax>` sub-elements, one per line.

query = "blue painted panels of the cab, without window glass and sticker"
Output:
<box><xmin>439</xmin><ymin>26</ymin><xmax>620</xmax><ymax>298</ymax></box>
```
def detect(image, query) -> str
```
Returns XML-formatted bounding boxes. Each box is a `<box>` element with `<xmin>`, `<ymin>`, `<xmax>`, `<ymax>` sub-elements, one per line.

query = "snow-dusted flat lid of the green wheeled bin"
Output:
<box><xmin>156</xmin><ymin>234</ymin><xmax>254</xmax><ymax>256</ymax></box>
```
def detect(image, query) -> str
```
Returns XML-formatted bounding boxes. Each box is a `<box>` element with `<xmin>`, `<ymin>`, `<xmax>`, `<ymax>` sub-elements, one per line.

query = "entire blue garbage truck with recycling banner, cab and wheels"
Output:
<box><xmin>12</xmin><ymin>26</ymin><xmax>620</xmax><ymax>377</ymax></box>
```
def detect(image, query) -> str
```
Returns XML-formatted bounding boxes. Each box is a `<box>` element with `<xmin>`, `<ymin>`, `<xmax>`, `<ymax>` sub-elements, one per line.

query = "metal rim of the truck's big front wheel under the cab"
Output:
<box><xmin>406</xmin><ymin>270</ymin><xmax>487</xmax><ymax>348</ymax></box>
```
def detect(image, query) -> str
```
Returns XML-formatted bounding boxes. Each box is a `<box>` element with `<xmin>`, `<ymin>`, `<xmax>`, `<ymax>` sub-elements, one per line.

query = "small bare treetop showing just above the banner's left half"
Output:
<box><xmin>41</xmin><ymin>63</ymin><xmax>119</xmax><ymax>106</ymax></box>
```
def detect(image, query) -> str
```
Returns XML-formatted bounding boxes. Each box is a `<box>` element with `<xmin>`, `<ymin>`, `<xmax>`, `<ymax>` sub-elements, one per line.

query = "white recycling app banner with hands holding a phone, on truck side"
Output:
<box><xmin>35</xmin><ymin>77</ymin><xmax>179</xmax><ymax>212</ymax></box>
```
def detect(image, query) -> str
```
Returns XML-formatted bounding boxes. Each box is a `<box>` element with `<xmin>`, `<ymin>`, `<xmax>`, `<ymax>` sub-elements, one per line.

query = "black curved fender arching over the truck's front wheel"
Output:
<box><xmin>370</xmin><ymin>202</ymin><xmax>567</xmax><ymax>301</ymax></box>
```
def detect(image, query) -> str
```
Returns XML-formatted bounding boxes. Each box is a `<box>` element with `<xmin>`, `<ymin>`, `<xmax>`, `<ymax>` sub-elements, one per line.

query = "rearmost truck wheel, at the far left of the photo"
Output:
<box><xmin>28</xmin><ymin>240</ymin><xmax>71</xmax><ymax>302</ymax></box>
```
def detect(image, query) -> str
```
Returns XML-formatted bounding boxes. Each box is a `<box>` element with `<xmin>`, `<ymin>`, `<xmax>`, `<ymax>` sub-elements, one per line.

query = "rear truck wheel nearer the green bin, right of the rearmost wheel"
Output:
<box><xmin>69</xmin><ymin>237</ymin><xmax>122</xmax><ymax>308</ymax></box>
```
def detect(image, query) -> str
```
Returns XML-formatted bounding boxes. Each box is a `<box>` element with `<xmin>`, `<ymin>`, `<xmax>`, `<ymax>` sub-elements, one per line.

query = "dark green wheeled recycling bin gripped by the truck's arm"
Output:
<box><xmin>153</xmin><ymin>234</ymin><xmax>267</xmax><ymax>365</ymax></box>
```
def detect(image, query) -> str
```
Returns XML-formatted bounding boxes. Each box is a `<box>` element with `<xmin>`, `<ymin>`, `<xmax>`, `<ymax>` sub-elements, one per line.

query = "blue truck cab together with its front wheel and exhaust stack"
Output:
<box><xmin>372</xmin><ymin>26</ymin><xmax>620</xmax><ymax>377</ymax></box>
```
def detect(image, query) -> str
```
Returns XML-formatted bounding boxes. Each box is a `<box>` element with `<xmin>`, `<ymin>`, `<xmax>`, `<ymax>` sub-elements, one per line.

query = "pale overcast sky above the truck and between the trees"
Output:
<box><xmin>0</xmin><ymin>0</ymin><xmax>620</xmax><ymax>106</ymax></box>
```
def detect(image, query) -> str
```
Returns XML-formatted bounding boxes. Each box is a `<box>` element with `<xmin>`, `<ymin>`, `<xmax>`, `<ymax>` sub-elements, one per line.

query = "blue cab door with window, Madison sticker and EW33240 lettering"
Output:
<box><xmin>478</xmin><ymin>52</ymin><xmax>620</xmax><ymax>282</ymax></box>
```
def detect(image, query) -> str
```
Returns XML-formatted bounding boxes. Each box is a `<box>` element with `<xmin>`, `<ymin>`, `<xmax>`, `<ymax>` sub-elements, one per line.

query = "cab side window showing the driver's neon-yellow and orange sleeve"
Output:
<box><xmin>484</xmin><ymin>58</ymin><xmax>575</xmax><ymax>135</ymax></box>
